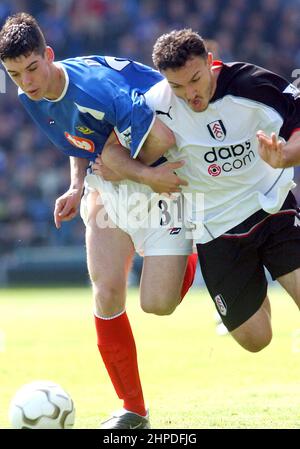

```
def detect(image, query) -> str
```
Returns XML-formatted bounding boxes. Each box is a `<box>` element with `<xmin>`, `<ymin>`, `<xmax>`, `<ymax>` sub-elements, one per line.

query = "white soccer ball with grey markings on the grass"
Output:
<box><xmin>9</xmin><ymin>380</ymin><xmax>75</xmax><ymax>429</ymax></box>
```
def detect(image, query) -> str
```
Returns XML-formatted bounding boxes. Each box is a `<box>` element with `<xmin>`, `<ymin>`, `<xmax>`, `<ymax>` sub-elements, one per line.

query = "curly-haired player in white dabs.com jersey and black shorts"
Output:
<box><xmin>102</xmin><ymin>29</ymin><xmax>300</xmax><ymax>352</ymax></box>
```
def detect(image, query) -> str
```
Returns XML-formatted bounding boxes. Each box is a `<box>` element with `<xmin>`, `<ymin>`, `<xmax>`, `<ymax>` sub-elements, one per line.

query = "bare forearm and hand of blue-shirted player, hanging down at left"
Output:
<box><xmin>54</xmin><ymin>156</ymin><xmax>89</xmax><ymax>229</ymax></box>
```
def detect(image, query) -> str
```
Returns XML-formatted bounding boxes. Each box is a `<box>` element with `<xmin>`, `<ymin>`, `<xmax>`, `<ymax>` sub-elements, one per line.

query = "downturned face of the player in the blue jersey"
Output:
<box><xmin>3</xmin><ymin>47</ymin><xmax>53</xmax><ymax>101</ymax></box>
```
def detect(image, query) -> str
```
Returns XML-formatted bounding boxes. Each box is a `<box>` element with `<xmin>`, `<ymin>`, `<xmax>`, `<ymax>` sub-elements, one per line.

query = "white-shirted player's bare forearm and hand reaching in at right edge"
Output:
<box><xmin>257</xmin><ymin>131</ymin><xmax>300</xmax><ymax>168</ymax></box>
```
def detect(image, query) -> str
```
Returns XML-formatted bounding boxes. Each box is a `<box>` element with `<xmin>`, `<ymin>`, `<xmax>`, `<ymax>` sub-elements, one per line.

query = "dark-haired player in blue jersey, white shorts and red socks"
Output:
<box><xmin>0</xmin><ymin>13</ymin><xmax>199</xmax><ymax>428</ymax></box>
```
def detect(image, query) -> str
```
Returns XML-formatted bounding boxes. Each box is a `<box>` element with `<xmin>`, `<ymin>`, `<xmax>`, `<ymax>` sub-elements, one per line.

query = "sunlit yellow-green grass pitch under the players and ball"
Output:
<box><xmin>0</xmin><ymin>288</ymin><xmax>300</xmax><ymax>429</ymax></box>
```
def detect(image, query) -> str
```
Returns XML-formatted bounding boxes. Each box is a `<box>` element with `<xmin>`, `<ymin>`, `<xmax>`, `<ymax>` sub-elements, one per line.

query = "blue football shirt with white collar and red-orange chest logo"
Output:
<box><xmin>19</xmin><ymin>55</ymin><xmax>162</xmax><ymax>160</ymax></box>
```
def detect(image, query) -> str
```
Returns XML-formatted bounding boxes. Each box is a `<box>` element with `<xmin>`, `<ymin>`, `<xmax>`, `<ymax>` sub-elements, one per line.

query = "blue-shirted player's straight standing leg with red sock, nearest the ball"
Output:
<box><xmin>86</xmin><ymin>188</ymin><xmax>146</xmax><ymax>420</ymax></box>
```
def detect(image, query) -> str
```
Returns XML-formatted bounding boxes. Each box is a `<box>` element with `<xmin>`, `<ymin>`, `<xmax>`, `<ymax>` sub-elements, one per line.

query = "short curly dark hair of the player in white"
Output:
<box><xmin>152</xmin><ymin>28</ymin><xmax>207</xmax><ymax>71</ymax></box>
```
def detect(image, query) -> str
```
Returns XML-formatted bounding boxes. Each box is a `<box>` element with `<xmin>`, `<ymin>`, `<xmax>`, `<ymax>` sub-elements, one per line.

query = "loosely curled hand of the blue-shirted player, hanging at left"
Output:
<box><xmin>54</xmin><ymin>189</ymin><xmax>82</xmax><ymax>229</ymax></box>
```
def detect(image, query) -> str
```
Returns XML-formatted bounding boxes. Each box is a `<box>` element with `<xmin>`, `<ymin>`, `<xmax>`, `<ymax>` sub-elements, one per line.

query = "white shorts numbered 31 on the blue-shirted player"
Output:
<box><xmin>80</xmin><ymin>174</ymin><xmax>193</xmax><ymax>256</ymax></box>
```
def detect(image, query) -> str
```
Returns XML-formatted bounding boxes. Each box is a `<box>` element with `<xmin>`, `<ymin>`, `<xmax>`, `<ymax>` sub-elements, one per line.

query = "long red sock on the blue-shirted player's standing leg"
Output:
<box><xmin>95</xmin><ymin>312</ymin><xmax>146</xmax><ymax>416</ymax></box>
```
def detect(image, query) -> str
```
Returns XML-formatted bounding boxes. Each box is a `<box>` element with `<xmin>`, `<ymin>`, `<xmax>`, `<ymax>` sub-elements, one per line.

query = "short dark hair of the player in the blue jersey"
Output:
<box><xmin>0</xmin><ymin>12</ymin><xmax>46</xmax><ymax>61</ymax></box>
